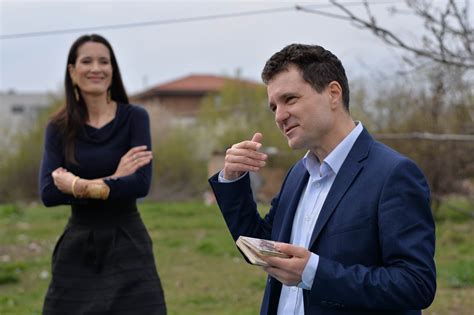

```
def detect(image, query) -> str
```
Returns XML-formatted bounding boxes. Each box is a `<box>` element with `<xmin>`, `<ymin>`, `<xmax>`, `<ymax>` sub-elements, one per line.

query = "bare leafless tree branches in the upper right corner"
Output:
<box><xmin>296</xmin><ymin>0</ymin><xmax>474</xmax><ymax>70</ymax></box>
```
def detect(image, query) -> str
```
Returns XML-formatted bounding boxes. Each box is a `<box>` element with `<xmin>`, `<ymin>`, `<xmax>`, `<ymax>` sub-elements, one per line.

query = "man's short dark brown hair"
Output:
<box><xmin>262</xmin><ymin>44</ymin><xmax>349</xmax><ymax>111</ymax></box>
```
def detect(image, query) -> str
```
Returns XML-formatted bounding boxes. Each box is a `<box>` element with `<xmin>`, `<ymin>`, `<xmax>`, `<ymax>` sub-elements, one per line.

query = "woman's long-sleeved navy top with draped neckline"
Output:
<box><xmin>39</xmin><ymin>104</ymin><xmax>152</xmax><ymax>211</ymax></box>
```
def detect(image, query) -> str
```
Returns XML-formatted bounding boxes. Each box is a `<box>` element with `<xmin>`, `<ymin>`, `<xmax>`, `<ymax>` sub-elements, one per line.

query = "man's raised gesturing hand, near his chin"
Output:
<box><xmin>224</xmin><ymin>132</ymin><xmax>267</xmax><ymax>180</ymax></box>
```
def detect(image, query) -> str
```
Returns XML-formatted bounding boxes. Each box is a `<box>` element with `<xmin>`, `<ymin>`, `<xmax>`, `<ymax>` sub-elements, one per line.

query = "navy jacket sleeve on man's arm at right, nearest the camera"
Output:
<box><xmin>307</xmin><ymin>160</ymin><xmax>436</xmax><ymax>310</ymax></box>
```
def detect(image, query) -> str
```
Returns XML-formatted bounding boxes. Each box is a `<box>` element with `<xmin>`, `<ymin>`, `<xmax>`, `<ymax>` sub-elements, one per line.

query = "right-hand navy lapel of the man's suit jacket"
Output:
<box><xmin>309</xmin><ymin>128</ymin><xmax>373</xmax><ymax>248</ymax></box>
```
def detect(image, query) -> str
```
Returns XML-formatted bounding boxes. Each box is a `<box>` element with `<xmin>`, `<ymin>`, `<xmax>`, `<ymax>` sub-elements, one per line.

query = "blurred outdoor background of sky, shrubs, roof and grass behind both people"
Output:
<box><xmin>0</xmin><ymin>0</ymin><xmax>474</xmax><ymax>314</ymax></box>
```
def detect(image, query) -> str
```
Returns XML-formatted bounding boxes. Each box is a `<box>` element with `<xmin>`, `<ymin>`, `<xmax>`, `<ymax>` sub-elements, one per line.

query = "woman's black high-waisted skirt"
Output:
<box><xmin>43</xmin><ymin>208</ymin><xmax>166</xmax><ymax>315</ymax></box>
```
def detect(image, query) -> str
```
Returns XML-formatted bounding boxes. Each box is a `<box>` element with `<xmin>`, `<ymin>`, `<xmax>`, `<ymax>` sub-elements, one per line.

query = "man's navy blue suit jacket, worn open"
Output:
<box><xmin>209</xmin><ymin>130</ymin><xmax>436</xmax><ymax>315</ymax></box>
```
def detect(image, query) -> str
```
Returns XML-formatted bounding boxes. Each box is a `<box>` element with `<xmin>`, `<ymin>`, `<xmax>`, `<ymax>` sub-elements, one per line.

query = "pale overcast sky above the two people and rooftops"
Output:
<box><xmin>0</xmin><ymin>0</ymin><xmax>420</xmax><ymax>94</ymax></box>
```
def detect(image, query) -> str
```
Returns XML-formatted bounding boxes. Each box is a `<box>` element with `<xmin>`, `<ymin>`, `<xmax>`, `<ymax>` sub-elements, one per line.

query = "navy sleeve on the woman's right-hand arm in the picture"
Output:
<box><xmin>104</xmin><ymin>106</ymin><xmax>152</xmax><ymax>200</ymax></box>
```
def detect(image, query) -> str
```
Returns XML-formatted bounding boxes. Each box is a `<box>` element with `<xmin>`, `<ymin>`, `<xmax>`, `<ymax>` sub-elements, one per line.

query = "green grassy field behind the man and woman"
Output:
<box><xmin>0</xmin><ymin>201</ymin><xmax>474</xmax><ymax>315</ymax></box>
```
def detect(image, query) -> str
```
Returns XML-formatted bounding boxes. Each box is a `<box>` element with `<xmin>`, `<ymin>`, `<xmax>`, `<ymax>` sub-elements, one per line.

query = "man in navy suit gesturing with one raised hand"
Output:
<box><xmin>209</xmin><ymin>44</ymin><xmax>436</xmax><ymax>315</ymax></box>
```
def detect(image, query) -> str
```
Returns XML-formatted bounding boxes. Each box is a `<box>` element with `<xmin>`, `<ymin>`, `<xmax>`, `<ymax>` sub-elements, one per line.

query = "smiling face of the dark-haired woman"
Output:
<box><xmin>68</xmin><ymin>42</ymin><xmax>113</xmax><ymax>97</ymax></box>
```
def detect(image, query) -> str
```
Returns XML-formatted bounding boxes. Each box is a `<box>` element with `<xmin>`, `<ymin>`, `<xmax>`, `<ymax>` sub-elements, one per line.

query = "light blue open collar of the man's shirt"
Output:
<box><xmin>303</xmin><ymin>121</ymin><xmax>364</xmax><ymax>177</ymax></box>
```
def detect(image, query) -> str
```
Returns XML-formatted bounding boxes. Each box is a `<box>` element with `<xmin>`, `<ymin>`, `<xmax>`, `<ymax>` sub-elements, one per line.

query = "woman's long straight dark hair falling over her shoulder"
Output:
<box><xmin>51</xmin><ymin>34</ymin><xmax>128</xmax><ymax>164</ymax></box>
